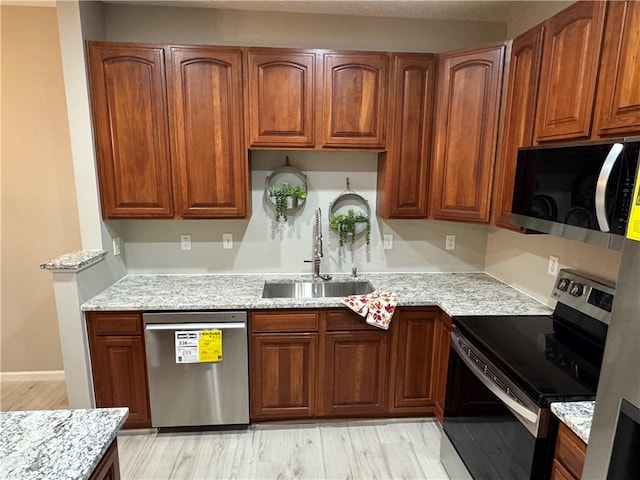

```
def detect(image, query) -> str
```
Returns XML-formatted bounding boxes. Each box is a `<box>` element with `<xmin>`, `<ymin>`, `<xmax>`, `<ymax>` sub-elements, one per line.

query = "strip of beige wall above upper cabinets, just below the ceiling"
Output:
<box><xmin>105</xmin><ymin>4</ymin><xmax>506</xmax><ymax>52</ymax></box>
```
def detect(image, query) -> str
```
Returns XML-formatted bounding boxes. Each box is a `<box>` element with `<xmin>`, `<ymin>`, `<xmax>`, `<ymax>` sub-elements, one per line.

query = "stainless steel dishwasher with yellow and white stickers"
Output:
<box><xmin>143</xmin><ymin>312</ymin><xmax>249</xmax><ymax>427</ymax></box>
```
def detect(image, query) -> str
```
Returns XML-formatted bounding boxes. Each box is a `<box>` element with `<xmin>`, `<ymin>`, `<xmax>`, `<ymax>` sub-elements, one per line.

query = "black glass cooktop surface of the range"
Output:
<box><xmin>453</xmin><ymin>316</ymin><xmax>602</xmax><ymax>407</ymax></box>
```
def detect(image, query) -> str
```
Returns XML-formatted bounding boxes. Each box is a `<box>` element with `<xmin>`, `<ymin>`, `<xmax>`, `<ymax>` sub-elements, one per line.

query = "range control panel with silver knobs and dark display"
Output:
<box><xmin>551</xmin><ymin>269</ymin><xmax>615</xmax><ymax>324</ymax></box>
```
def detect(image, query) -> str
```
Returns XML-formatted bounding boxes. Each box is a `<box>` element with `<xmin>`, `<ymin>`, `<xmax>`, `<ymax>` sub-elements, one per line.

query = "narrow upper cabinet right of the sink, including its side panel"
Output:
<box><xmin>378</xmin><ymin>55</ymin><xmax>435</xmax><ymax>218</ymax></box>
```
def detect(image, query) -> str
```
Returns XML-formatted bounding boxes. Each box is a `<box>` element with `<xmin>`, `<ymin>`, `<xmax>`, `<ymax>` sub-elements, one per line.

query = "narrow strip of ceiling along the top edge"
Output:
<box><xmin>105</xmin><ymin>0</ymin><xmax>541</xmax><ymax>23</ymax></box>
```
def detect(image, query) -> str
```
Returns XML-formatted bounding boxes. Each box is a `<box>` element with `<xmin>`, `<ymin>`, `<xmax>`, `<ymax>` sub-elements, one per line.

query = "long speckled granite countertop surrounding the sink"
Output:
<box><xmin>82</xmin><ymin>273</ymin><xmax>551</xmax><ymax>316</ymax></box>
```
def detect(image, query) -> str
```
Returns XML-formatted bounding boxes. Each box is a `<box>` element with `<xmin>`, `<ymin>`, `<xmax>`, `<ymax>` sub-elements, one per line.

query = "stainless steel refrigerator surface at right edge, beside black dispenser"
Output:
<box><xmin>583</xmin><ymin>239</ymin><xmax>640</xmax><ymax>479</ymax></box>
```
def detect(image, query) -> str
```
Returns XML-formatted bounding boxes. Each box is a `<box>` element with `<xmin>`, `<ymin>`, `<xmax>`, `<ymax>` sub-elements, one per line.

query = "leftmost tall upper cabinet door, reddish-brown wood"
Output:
<box><xmin>88</xmin><ymin>43</ymin><xmax>173</xmax><ymax>219</ymax></box>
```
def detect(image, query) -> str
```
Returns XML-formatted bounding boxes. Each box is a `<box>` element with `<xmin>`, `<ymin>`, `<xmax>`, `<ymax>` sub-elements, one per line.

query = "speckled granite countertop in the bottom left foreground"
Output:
<box><xmin>0</xmin><ymin>408</ymin><xmax>129</xmax><ymax>480</ymax></box>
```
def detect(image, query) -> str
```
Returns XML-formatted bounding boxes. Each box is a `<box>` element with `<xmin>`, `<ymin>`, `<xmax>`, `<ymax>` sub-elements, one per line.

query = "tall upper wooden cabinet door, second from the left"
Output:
<box><xmin>169</xmin><ymin>47</ymin><xmax>249</xmax><ymax>218</ymax></box>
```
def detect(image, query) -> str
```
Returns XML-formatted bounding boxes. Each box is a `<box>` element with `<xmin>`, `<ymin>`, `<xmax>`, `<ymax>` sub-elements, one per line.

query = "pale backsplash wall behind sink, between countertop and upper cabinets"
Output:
<box><xmin>121</xmin><ymin>151</ymin><xmax>487</xmax><ymax>273</ymax></box>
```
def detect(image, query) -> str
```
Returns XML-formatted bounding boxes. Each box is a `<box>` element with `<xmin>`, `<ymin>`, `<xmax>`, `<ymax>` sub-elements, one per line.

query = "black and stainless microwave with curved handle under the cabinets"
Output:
<box><xmin>511</xmin><ymin>137</ymin><xmax>640</xmax><ymax>250</ymax></box>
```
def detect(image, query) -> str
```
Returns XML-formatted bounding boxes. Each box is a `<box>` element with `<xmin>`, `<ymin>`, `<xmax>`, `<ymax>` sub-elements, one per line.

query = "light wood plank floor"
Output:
<box><xmin>0</xmin><ymin>382</ymin><xmax>448</xmax><ymax>480</ymax></box>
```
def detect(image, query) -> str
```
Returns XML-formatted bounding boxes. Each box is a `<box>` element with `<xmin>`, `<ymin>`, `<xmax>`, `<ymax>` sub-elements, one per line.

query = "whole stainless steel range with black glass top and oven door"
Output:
<box><xmin>441</xmin><ymin>270</ymin><xmax>614</xmax><ymax>480</ymax></box>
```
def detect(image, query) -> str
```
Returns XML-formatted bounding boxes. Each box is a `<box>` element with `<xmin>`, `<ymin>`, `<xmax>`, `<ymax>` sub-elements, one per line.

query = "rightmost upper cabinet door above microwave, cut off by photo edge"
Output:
<box><xmin>594</xmin><ymin>2</ymin><xmax>640</xmax><ymax>137</ymax></box>
